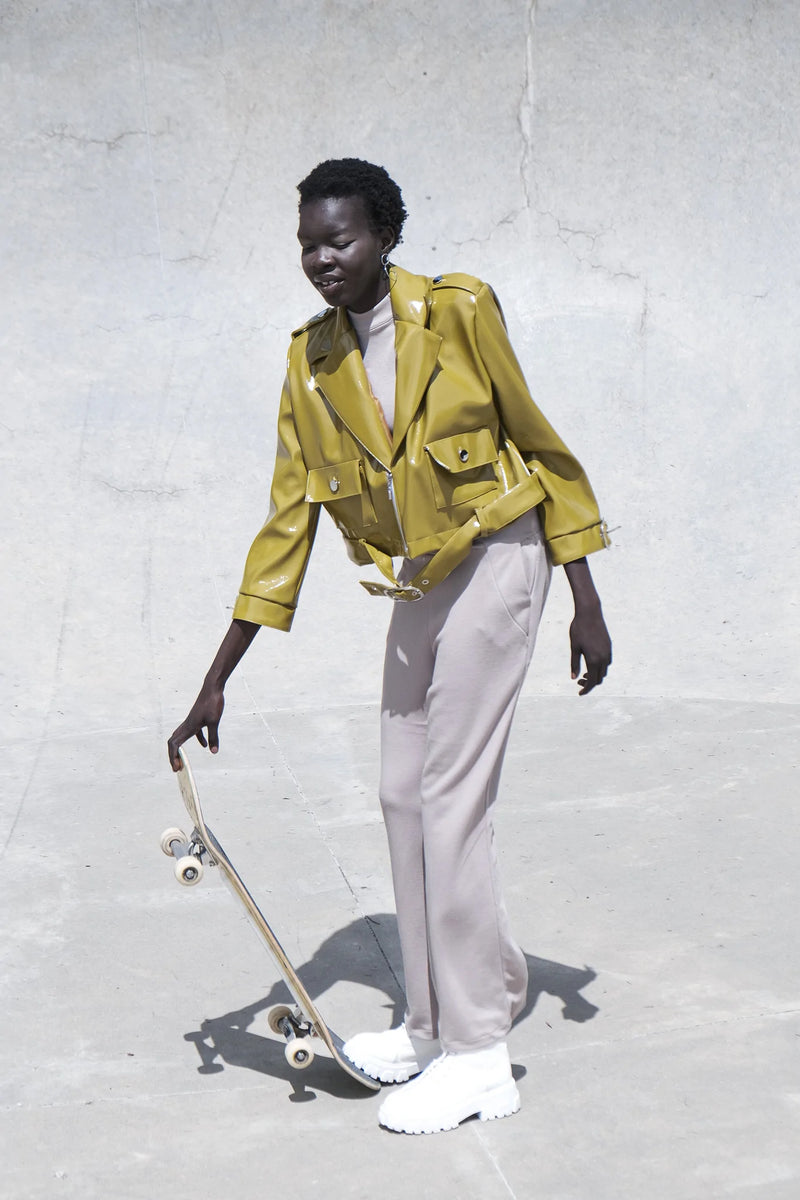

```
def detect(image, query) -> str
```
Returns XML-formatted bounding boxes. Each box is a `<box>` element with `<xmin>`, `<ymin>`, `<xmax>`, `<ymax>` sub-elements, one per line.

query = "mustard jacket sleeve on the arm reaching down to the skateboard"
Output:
<box><xmin>234</xmin><ymin>379</ymin><xmax>320</xmax><ymax>632</ymax></box>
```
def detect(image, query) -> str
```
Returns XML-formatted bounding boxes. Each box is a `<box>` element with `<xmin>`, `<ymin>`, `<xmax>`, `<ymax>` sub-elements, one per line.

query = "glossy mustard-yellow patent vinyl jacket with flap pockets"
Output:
<box><xmin>234</xmin><ymin>268</ymin><xmax>608</xmax><ymax>630</ymax></box>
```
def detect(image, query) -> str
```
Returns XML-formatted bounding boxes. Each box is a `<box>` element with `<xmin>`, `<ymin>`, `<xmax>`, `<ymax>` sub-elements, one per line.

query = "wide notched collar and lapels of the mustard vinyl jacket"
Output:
<box><xmin>306</xmin><ymin>266</ymin><xmax>441</xmax><ymax>463</ymax></box>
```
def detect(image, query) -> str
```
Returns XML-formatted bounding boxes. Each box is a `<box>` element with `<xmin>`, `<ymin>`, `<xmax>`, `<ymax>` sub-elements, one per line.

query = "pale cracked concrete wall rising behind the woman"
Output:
<box><xmin>0</xmin><ymin>0</ymin><xmax>800</xmax><ymax>739</ymax></box>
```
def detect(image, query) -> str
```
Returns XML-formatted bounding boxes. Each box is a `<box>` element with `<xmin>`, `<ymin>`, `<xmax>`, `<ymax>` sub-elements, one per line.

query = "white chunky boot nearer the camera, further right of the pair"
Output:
<box><xmin>378</xmin><ymin>1042</ymin><xmax>519</xmax><ymax>1133</ymax></box>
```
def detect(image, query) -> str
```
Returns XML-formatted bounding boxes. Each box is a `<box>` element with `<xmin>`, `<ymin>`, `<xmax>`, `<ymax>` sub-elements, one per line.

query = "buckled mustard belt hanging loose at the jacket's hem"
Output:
<box><xmin>359</xmin><ymin>474</ymin><xmax>542</xmax><ymax>600</ymax></box>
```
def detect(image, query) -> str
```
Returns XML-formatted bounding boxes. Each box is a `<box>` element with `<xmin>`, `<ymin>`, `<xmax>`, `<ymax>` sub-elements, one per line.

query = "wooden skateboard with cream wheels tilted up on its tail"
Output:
<box><xmin>161</xmin><ymin>750</ymin><xmax>380</xmax><ymax>1092</ymax></box>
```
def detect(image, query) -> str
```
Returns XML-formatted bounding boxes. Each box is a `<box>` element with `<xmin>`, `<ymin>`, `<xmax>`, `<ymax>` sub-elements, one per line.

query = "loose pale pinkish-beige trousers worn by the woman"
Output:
<box><xmin>380</xmin><ymin>510</ymin><xmax>551</xmax><ymax>1050</ymax></box>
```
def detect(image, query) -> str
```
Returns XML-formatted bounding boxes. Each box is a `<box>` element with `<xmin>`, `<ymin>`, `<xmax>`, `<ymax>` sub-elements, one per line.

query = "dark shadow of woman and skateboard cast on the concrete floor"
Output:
<box><xmin>179</xmin><ymin>913</ymin><xmax>599</xmax><ymax>1103</ymax></box>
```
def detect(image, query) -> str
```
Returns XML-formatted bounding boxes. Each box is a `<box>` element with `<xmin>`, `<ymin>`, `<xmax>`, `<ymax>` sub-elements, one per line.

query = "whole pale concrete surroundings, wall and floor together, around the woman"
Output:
<box><xmin>0</xmin><ymin>0</ymin><xmax>800</xmax><ymax>1200</ymax></box>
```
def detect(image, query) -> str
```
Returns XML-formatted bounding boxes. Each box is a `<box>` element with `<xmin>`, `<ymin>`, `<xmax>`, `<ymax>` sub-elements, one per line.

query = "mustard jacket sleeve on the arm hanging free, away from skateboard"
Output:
<box><xmin>475</xmin><ymin>283</ymin><xmax>608</xmax><ymax>565</ymax></box>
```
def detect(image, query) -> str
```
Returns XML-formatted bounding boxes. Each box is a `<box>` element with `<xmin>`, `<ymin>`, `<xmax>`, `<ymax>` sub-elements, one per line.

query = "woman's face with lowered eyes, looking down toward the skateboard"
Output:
<box><xmin>297</xmin><ymin>196</ymin><xmax>395</xmax><ymax>312</ymax></box>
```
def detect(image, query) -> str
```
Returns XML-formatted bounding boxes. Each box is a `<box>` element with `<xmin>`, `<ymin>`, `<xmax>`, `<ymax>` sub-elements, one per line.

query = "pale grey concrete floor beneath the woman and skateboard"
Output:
<box><xmin>0</xmin><ymin>695</ymin><xmax>800</xmax><ymax>1200</ymax></box>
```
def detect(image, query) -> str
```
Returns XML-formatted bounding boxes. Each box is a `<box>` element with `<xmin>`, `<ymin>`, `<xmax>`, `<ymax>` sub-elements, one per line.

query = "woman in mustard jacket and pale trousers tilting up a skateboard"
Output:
<box><xmin>168</xmin><ymin>158</ymin><xmax>610</xmax><ymax>1133</ymax></box>
